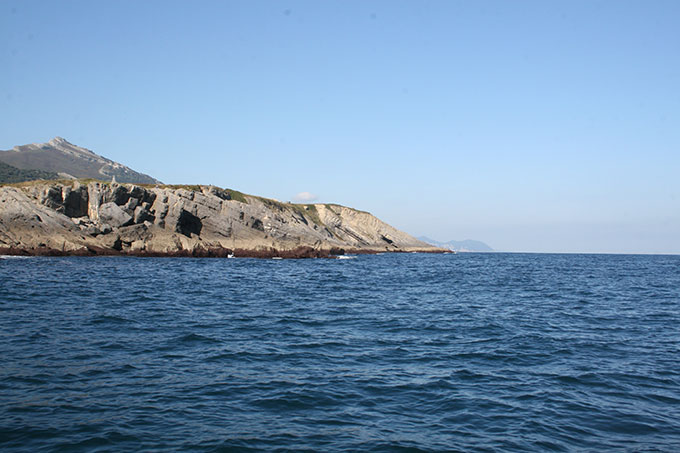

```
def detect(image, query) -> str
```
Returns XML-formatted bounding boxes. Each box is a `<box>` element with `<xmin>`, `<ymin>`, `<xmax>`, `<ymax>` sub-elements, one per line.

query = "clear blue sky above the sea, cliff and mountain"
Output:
<box><xmin>0</xmin><ymin>0</ymin><xmax>680</xmax><ymax>253</ymax></box>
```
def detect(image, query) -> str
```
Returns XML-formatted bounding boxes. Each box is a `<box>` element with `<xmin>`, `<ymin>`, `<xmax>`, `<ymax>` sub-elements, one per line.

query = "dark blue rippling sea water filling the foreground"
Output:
<box><xmin>0</xmin><ymin>254</ymin><xmax>680</xmax><ymax>452</ymax></box>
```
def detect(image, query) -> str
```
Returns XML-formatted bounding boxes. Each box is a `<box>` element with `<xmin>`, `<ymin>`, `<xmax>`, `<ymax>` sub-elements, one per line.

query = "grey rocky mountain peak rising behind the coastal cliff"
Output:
<box><xmin>0</xmin><ymin>137</ymin><xmax>160</xmax><ymax>184</ymax></box>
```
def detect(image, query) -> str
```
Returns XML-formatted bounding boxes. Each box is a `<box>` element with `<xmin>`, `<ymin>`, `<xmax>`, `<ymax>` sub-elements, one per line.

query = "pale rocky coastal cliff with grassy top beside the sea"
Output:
<box><xmin>0</xmin><ymin>181</ymin><xmax>440</xmax><ymax>256</ymax></box>
